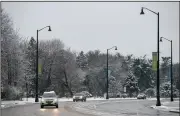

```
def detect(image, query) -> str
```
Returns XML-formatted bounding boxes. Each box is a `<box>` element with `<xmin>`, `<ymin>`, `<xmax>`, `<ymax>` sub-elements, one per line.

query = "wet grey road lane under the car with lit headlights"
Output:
<box><xmin>1</xmin><ymin>102</ymin><xmax>86</xmax><ymax>116</ymax></box>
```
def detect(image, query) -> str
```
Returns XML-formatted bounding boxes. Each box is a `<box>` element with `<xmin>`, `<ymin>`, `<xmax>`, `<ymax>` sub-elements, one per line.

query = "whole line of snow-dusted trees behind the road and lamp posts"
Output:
<box><xmin>1</xmin><ymin>10</ymin><xmax>180</xmax><ymax>99</ymax></box>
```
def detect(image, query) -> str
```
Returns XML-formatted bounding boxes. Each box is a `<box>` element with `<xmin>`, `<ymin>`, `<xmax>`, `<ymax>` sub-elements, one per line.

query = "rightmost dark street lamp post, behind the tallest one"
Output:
<box><xmin>160</xmin><ymin>37</ymin><xmax>174</xmax><ymax>101</ymax></box>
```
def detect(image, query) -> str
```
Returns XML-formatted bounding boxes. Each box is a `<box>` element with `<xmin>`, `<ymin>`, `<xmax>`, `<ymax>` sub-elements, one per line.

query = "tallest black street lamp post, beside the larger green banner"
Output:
<box><xmin>140</xmin><ymin>7</ymin><xmax>161</xmax><ymax>106</ymax></box>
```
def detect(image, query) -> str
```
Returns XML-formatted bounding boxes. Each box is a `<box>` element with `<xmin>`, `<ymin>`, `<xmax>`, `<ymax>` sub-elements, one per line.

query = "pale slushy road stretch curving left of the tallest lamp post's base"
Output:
<box><xmin>96</xmin><ymin>100</ymin><xmax>179</xmax><ymax>116</ymax></box>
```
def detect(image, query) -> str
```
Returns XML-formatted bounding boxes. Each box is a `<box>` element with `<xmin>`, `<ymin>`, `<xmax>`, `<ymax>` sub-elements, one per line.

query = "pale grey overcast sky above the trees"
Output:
<box><xmin>2</xmin><ymin>2</ymin><xmax>179</xmax><ymax>62</ymax></box>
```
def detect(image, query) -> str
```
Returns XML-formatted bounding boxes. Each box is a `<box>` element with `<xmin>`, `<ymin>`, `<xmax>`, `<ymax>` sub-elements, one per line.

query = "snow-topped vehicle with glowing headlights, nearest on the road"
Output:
<box><xmin>40</xmin><ymin>91</ymin><xmax>58</xmax><ymax>108</ymax></box>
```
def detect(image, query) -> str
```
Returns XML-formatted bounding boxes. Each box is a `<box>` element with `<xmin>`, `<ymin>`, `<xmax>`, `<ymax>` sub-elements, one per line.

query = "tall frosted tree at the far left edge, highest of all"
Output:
<box><xmin>1</xmin><ymin>9</ymin><xmax>23</xmax><ymax>98</ymax></box>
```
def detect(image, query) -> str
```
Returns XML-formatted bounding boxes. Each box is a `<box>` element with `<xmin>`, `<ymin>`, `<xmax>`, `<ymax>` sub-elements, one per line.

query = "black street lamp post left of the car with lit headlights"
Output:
<box><xmin>35</xmin><ymin>26</ymin><xmax>51</xmax><ymax>102</ymax></box>
